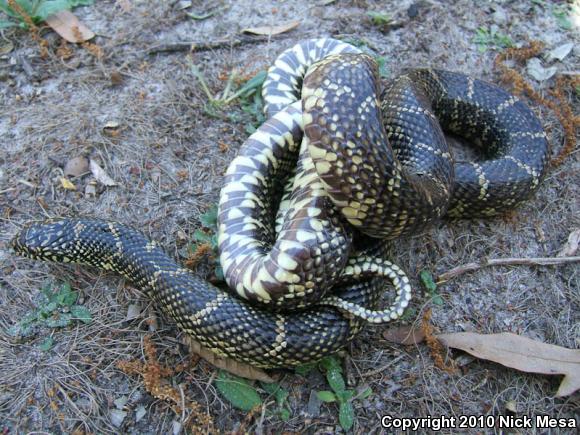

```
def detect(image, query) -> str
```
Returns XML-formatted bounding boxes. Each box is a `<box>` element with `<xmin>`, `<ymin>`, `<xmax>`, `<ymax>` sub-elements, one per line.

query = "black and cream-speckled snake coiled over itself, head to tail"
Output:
<box><xmin>11</xmin><ymin>38</ymin><xmax>548</xmax><ymax>368</ymax></box>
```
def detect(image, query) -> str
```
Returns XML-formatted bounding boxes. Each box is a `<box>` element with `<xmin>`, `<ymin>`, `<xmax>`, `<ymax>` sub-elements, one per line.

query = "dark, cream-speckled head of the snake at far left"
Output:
<box><xmin>10</xmin><ymin>219</ymin><xmax>71</xmax><ymax>261</ymax></box>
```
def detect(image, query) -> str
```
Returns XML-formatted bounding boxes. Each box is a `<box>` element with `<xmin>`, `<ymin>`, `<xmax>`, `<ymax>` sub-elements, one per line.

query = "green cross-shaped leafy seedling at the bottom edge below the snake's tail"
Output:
<box><xmin>316</xmin><ymin>356</ymin><xmax>373</xmax><ymax>431</ymax></box>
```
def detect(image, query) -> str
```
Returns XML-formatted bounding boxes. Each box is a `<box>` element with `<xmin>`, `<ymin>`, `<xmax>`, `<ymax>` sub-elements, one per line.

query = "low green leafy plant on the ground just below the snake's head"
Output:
<box><xmin>8</xmin><ymin>283</ymin><xmax>92</xmax><ymax>344</ymax></box>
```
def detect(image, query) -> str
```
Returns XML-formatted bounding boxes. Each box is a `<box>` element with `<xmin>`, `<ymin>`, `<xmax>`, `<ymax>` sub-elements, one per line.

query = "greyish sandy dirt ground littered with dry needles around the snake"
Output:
<box><xmin>0</xmin><ymin>0</ymin><xmax>580</xmax><ymax>433</ymax></box>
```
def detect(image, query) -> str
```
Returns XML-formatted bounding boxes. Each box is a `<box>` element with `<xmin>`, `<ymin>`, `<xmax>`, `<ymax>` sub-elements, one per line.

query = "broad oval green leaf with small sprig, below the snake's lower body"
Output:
<box><xmin>215</xmin><ymin>370</ymin><xmax>291</xmax><ymax>421</ymax></box>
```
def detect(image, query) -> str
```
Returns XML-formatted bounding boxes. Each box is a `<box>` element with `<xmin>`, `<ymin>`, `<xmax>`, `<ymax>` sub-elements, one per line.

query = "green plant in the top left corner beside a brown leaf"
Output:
<box><xmin>0</xmin><ymin>0</ymin><xmax>94</xmax><ymax>29</ymax></box>
